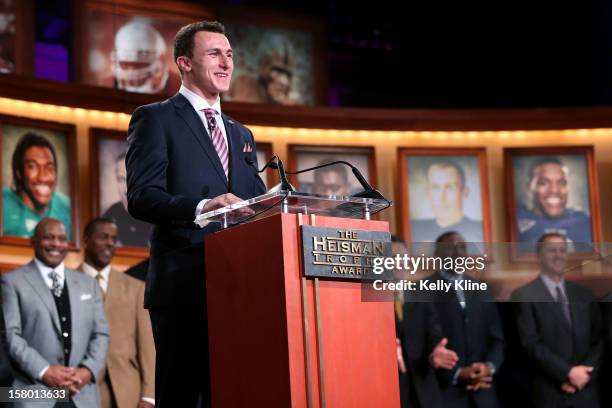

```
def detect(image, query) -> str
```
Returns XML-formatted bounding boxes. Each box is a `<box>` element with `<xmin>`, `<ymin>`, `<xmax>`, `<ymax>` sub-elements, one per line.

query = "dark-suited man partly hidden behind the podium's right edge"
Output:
<box><xmin>391</xmin><ymin>236</ymin><xmax>458</xmax><ymax>408</ymax></box>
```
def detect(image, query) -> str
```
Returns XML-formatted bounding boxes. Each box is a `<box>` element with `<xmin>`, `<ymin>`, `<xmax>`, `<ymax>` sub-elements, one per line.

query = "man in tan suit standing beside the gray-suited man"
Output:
<box><xmin>78</xmin><ymin>218</ymin><xmax>155</xmax><ymax>408</ymax></box>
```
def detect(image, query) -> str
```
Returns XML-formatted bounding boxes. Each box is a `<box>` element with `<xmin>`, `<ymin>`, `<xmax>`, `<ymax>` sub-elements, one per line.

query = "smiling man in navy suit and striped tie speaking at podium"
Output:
<box><xmin>126</xmin><ymin>21</ymin><xmax>265</xmax><ymax>408</ymax></box>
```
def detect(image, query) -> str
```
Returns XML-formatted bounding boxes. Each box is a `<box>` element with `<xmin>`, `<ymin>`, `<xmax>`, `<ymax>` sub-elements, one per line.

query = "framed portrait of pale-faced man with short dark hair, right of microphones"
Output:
<box><xmin>397</xmin><ymin>147</ymin><xmax>491</xmax><ymax>252</ymax></box>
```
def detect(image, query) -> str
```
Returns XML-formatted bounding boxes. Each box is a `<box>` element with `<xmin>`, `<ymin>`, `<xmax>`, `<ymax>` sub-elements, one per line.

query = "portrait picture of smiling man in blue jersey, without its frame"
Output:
<box><xmin>513</xmin><ymin>155</ymin><xmax>593</xmax><ymax>252</ymax></box>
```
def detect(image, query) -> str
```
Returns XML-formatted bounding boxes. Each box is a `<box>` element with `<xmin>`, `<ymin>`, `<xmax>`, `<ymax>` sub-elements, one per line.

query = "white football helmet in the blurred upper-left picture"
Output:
<box><xmin>111</xmin><ymin>18</ymin><xmax>169</xmax><ymax>93</ymax></box>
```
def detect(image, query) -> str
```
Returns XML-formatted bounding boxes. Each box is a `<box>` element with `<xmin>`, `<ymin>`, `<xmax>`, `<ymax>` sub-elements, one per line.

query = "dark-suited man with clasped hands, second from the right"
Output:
<box><xmin>427</xmin><ymin>231</ymin><xmax>504</xmax><ymax>408</ymax></box>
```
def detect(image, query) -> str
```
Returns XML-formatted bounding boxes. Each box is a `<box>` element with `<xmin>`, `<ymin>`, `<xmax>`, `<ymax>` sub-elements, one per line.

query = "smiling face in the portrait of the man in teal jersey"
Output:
<box><xmin>19</xmin><ymin>146</ymin><xmax>57</xmax><ymax>212</ymax></box>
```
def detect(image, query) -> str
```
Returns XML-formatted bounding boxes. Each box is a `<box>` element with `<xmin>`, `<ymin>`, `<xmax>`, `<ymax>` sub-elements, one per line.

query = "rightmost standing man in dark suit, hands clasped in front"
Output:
<box><xmin>511</xmin><ymin>233</ymin><xmax>603</xmax><ymax>408</ymax></box>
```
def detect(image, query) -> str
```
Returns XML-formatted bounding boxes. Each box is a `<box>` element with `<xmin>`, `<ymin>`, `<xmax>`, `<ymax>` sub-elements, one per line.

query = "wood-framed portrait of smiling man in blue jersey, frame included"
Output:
<box><xmin>504</xmin><ymin>146</ymin><xmax>601</xmax><ymax>259</ymax></box>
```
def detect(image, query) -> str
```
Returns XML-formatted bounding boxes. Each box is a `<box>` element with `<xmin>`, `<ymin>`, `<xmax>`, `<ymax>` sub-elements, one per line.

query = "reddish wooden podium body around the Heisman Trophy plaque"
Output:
<box><xmin>205</xmin><ymin>214</ymin><xmax>399</xmax><ymax>408</ymax></box>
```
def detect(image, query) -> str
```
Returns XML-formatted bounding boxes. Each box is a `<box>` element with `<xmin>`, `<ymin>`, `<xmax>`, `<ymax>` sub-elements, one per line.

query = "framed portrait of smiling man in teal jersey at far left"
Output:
<box><xmin>0</xmin><ymin>115</ymin><xmax>80</xmax><ymax>249</ymax></box>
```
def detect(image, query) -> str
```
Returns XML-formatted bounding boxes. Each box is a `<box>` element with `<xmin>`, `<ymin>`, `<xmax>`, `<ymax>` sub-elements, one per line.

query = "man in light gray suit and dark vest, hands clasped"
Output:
<box><xmin>2</xmin><ymin>218</ymin><xmax>109</xmax><ymax>408</ymax></box>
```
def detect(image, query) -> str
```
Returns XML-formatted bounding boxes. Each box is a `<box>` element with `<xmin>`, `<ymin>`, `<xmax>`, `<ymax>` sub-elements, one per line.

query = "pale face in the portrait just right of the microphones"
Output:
<box><xmin>427</xmin><ymin>164</ymin><xmax>468</xmax><ymax>222</ymax></box>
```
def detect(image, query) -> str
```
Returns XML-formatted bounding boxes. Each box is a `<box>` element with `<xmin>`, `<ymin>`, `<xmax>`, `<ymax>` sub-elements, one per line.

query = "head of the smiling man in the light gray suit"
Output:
<box><xmin>32</xmin><ymin>218</ymin><xmax>68</xmax><ymax>268</ymax></box>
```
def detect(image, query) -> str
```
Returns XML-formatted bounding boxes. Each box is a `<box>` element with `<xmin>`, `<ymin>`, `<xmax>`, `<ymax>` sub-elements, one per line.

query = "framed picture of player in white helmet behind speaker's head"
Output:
<box><xmin>75</xmin><ymin>0</ymin><xmax>210</xmax><ymax>95</ymax></box>
